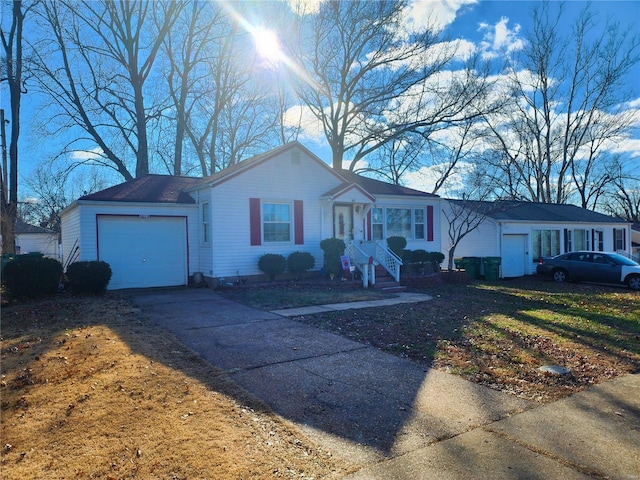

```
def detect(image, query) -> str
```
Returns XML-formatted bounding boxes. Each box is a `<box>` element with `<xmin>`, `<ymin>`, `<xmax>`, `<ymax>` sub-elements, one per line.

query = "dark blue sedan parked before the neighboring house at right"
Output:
<box><xmin>536</xmin><ymin>252</ymin><xmax>640</xmax><ymax>290</ymax></box>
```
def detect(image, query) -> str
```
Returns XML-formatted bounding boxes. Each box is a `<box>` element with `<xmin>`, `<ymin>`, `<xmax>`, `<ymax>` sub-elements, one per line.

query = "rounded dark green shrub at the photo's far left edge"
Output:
<box><xmin>2</xmin><ymin>254</ymin><xmax>62</xmax><ymax>299</ymax></box>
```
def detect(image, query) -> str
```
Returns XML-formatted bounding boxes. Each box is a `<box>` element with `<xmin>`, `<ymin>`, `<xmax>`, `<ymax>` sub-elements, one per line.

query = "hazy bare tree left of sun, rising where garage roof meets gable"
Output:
<box><xmin>179</xmin><ymin>13</ymin><xmax>282</xmax><ymax>175</ymax></box>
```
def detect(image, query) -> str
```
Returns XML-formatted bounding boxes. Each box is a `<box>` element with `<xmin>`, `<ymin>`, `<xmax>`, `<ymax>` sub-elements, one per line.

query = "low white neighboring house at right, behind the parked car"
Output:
<box><xmin>441</xmin><ymin>200</ymin><xmax>632</xmax><ymax>277</ymax></box>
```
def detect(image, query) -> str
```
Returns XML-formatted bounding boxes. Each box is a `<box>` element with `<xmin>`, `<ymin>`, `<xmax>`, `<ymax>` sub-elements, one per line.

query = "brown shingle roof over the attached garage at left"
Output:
<box><xmin>80</xmin><ymin>175</ymin><xmax>202</xmax><ymax>204</ymax></box>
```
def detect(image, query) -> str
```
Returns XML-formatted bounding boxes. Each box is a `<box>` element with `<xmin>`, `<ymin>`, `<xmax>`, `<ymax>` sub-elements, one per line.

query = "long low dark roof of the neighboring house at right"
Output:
<box><xmin>448</xmin><ymin>199</ymin><xmax>629</xmax><ymax>223</ymax></box>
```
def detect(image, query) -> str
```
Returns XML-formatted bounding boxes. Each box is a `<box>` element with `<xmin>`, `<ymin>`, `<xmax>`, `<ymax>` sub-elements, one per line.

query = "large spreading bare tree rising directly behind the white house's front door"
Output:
<box><xmin>291</xmin><ymin>1</ymin><xmax>488</xmax><ymax>170</ymax></box>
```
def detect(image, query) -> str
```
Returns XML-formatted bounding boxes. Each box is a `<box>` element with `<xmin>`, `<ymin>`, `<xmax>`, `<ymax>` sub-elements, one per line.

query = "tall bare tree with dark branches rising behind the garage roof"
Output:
<box><xmin>33</xmin><ymin>0</ymin><xmax>183</xmax><ymax>180</ymax></box>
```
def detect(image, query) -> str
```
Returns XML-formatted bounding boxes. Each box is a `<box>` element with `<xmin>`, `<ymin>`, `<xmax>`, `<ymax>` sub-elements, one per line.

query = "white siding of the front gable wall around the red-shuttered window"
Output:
<box><xmin>211</xmin><ymin>151</ymin><xmax>341</xmax><ymax>280</ymax></box>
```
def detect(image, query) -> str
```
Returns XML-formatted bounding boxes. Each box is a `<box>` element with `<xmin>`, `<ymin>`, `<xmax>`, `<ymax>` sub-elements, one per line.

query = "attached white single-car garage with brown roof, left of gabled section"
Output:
<box><xmin>60</xmin><ymin>175</ymin><xmax>201</xmax><ymax>290</ymax></box>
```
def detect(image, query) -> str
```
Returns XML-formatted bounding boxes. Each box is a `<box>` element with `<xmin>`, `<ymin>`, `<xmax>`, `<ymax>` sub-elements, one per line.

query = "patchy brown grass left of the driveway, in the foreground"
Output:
<box><xmin>0</xmin><ymin>294</ymin><xmax>349</xmax><ymax>479</ymax></box>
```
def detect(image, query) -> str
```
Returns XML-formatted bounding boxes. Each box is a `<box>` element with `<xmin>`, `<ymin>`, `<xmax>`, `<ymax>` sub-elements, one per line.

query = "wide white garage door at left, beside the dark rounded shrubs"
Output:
<box><xmin>98</xmin><ymin>215</ymin><xmax>187</xmax><ymax>290</ymax></box>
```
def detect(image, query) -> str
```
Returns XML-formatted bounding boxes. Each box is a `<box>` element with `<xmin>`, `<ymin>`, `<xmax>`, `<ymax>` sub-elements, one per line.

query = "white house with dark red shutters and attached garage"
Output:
<box><xmin>60</xmin><ymin>142</ymin><xmax>441</xmax><ymax>289</ymax></box>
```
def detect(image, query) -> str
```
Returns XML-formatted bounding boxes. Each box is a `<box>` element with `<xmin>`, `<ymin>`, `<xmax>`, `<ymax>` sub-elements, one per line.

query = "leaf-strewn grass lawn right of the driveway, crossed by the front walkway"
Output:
<box><xmin>223</xmin><ymin>274</ymin><xmax>640</xmax><ymax>403</ymax></box>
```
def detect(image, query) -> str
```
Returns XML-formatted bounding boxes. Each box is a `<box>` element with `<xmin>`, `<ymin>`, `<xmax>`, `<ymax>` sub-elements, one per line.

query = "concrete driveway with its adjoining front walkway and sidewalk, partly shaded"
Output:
<box><xmin>132</xmin><ymin>289</ymin><xmax>640</xmax><ymax>480</ymax></box>
